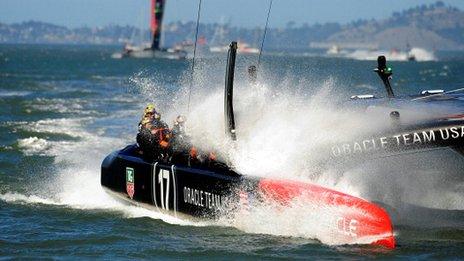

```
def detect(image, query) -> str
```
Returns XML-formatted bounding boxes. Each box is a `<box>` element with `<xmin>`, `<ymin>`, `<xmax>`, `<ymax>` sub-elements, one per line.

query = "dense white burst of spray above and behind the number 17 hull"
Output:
<box><xmin>183</xmin><ymin>80</ymin><xmax>388</xmax><ymax>178</ymax></box>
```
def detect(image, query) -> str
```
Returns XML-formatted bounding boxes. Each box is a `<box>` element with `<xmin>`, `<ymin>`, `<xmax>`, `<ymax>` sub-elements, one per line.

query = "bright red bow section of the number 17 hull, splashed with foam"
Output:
<box><xmin>259</xmin><ymin>179</ymin><xmax>395</xmax><ymax>248</ymax></box>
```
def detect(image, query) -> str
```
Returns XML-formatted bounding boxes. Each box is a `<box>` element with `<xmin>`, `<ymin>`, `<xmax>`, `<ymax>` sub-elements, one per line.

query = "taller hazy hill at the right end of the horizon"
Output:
<box><xmin>325</xmin><ymin>2</ymin><xmax>464</xmax><ymax>50</ymax></box>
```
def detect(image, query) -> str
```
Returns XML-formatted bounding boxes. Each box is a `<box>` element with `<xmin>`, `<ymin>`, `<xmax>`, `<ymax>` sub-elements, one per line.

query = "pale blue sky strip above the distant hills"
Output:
<box><xmin>0</xmin><ymin>0</ymin><xmax>464</xmax><ymax>28</ymax></box>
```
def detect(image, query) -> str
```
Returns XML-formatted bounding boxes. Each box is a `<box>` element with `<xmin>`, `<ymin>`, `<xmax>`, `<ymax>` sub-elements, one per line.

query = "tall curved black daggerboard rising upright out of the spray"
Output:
<box><xmin>224</xmin><ymin>42</ymin><xmax>237</xmax><ymax>140</ymax></box>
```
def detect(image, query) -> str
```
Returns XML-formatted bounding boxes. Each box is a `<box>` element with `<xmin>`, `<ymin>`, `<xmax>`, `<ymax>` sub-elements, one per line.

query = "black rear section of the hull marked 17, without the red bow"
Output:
<box><xmin>101</xmin><ymin>145</ymin><xmax>250</xmax><ymax>218</ymax></box>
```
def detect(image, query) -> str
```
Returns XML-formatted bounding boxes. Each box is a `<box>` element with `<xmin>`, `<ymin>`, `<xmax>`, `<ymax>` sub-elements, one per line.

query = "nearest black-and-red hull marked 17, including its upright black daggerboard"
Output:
<box><xmin>101</xmin><ymin>42</ymin><xmax>395</xmax><ymax>248</ymax></box>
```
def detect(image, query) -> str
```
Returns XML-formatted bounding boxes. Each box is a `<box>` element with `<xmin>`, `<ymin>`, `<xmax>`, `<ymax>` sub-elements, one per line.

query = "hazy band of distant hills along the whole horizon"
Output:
<box><xmin>0</xmin><ymin>1</ymin><xmax>464</xmax><ymax>50</ymax></box>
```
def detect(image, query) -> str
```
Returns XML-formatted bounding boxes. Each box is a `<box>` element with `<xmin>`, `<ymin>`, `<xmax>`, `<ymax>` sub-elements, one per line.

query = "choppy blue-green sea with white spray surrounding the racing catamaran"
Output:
<box><xmin>0</xmin><ymin>45</ymin><xmax>464</xmax><ymax>259</ymax></box>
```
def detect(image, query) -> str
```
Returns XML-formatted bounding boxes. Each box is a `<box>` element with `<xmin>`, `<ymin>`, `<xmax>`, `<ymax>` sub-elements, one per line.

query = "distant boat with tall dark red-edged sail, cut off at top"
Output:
<box><xmin>111</xmin><ymin>0</ymin><xmax>187</xmax><ymax>59</ymax></box>
